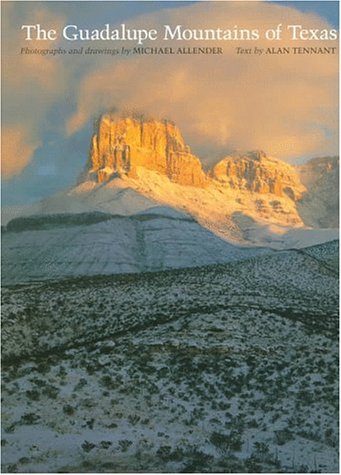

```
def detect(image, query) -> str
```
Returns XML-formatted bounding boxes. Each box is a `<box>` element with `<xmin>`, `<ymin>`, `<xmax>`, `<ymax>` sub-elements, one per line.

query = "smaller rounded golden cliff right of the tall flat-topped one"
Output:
<box><xmin>212</xmin><ymin>151</ymin><xmax>305</xmax><ymax>201</ymax></box>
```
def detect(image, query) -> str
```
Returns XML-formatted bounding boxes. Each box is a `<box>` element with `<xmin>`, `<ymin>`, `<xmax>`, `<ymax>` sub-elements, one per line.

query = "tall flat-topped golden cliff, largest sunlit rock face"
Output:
<box><xmin>86</xmin><ymin>114</ymin><xmax>207</xmax><ymax>187</ymax></box>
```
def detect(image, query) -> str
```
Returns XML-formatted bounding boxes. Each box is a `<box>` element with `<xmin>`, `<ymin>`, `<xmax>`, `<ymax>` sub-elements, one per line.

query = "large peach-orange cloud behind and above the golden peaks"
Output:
<box><xmin>67</xmin><ymin>2</ymin><xmax>338</xmax><ymax>161</ymax></box>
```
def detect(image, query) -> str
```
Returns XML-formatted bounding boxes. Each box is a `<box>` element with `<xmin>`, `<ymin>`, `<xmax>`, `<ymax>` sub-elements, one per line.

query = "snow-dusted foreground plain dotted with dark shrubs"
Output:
<box><xmin>2</xmin><ymin>243</ymin><xmax>338</xmax><ymax>473</ymax></box>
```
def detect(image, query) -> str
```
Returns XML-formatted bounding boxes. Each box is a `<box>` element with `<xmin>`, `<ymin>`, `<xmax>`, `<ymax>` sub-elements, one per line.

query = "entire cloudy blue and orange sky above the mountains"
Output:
<box><xmin>2</xmin><ymin>1</ymin><xmax>338</xmax><ymax>204</ymax></box>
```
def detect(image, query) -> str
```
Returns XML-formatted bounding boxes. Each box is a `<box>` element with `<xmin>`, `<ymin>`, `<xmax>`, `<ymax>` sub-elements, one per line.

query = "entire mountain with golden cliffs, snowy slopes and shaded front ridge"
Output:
<box><xmin>2</xmin><ymin>113</ymin><xmax>339</xmax><ymax>284</ymax></box>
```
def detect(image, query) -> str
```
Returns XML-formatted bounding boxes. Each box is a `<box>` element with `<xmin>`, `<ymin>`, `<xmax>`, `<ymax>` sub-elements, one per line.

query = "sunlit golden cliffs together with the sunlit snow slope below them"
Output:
<box><xmin>72</xmin><ymin>113</ymin><xmax>337</xmax><ymax>248</ymax></box>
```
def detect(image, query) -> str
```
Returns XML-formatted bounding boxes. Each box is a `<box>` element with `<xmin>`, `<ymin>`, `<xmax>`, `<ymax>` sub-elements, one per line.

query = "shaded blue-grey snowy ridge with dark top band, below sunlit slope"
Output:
<box><xmin>2</xmin><ymin>207</ymin><xmax>265</xmax><ymax>284</ymax></box>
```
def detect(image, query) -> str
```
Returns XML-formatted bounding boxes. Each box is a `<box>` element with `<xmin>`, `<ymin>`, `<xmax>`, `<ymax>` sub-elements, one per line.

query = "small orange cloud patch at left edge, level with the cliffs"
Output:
<box><xmin>1</xmin><ymin>126</ymin><xmax>39</xmax><ymax>178</ymax></box>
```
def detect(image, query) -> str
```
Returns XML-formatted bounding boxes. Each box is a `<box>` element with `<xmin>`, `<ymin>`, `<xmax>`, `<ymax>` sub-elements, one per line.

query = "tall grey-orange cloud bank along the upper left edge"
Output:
<box><xmin>2</xmin><ymin>2</ymin><xmax>67</xmax><ymax>178</ymax></box>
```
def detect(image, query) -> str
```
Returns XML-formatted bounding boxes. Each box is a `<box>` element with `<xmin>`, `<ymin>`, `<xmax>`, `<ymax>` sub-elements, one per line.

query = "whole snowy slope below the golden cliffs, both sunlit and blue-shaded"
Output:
<box><xmin>3</xmin><ymin>167</ymin><xmax>338</xmax><ymax>253</ymax></box>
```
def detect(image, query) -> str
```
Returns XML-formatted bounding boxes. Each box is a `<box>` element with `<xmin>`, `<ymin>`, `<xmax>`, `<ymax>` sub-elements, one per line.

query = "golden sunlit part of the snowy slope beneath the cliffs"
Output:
<box><xmin>103</xmin><ymin>167</ymin><xmax>338</xmax><ymax>249</ymax></box>
